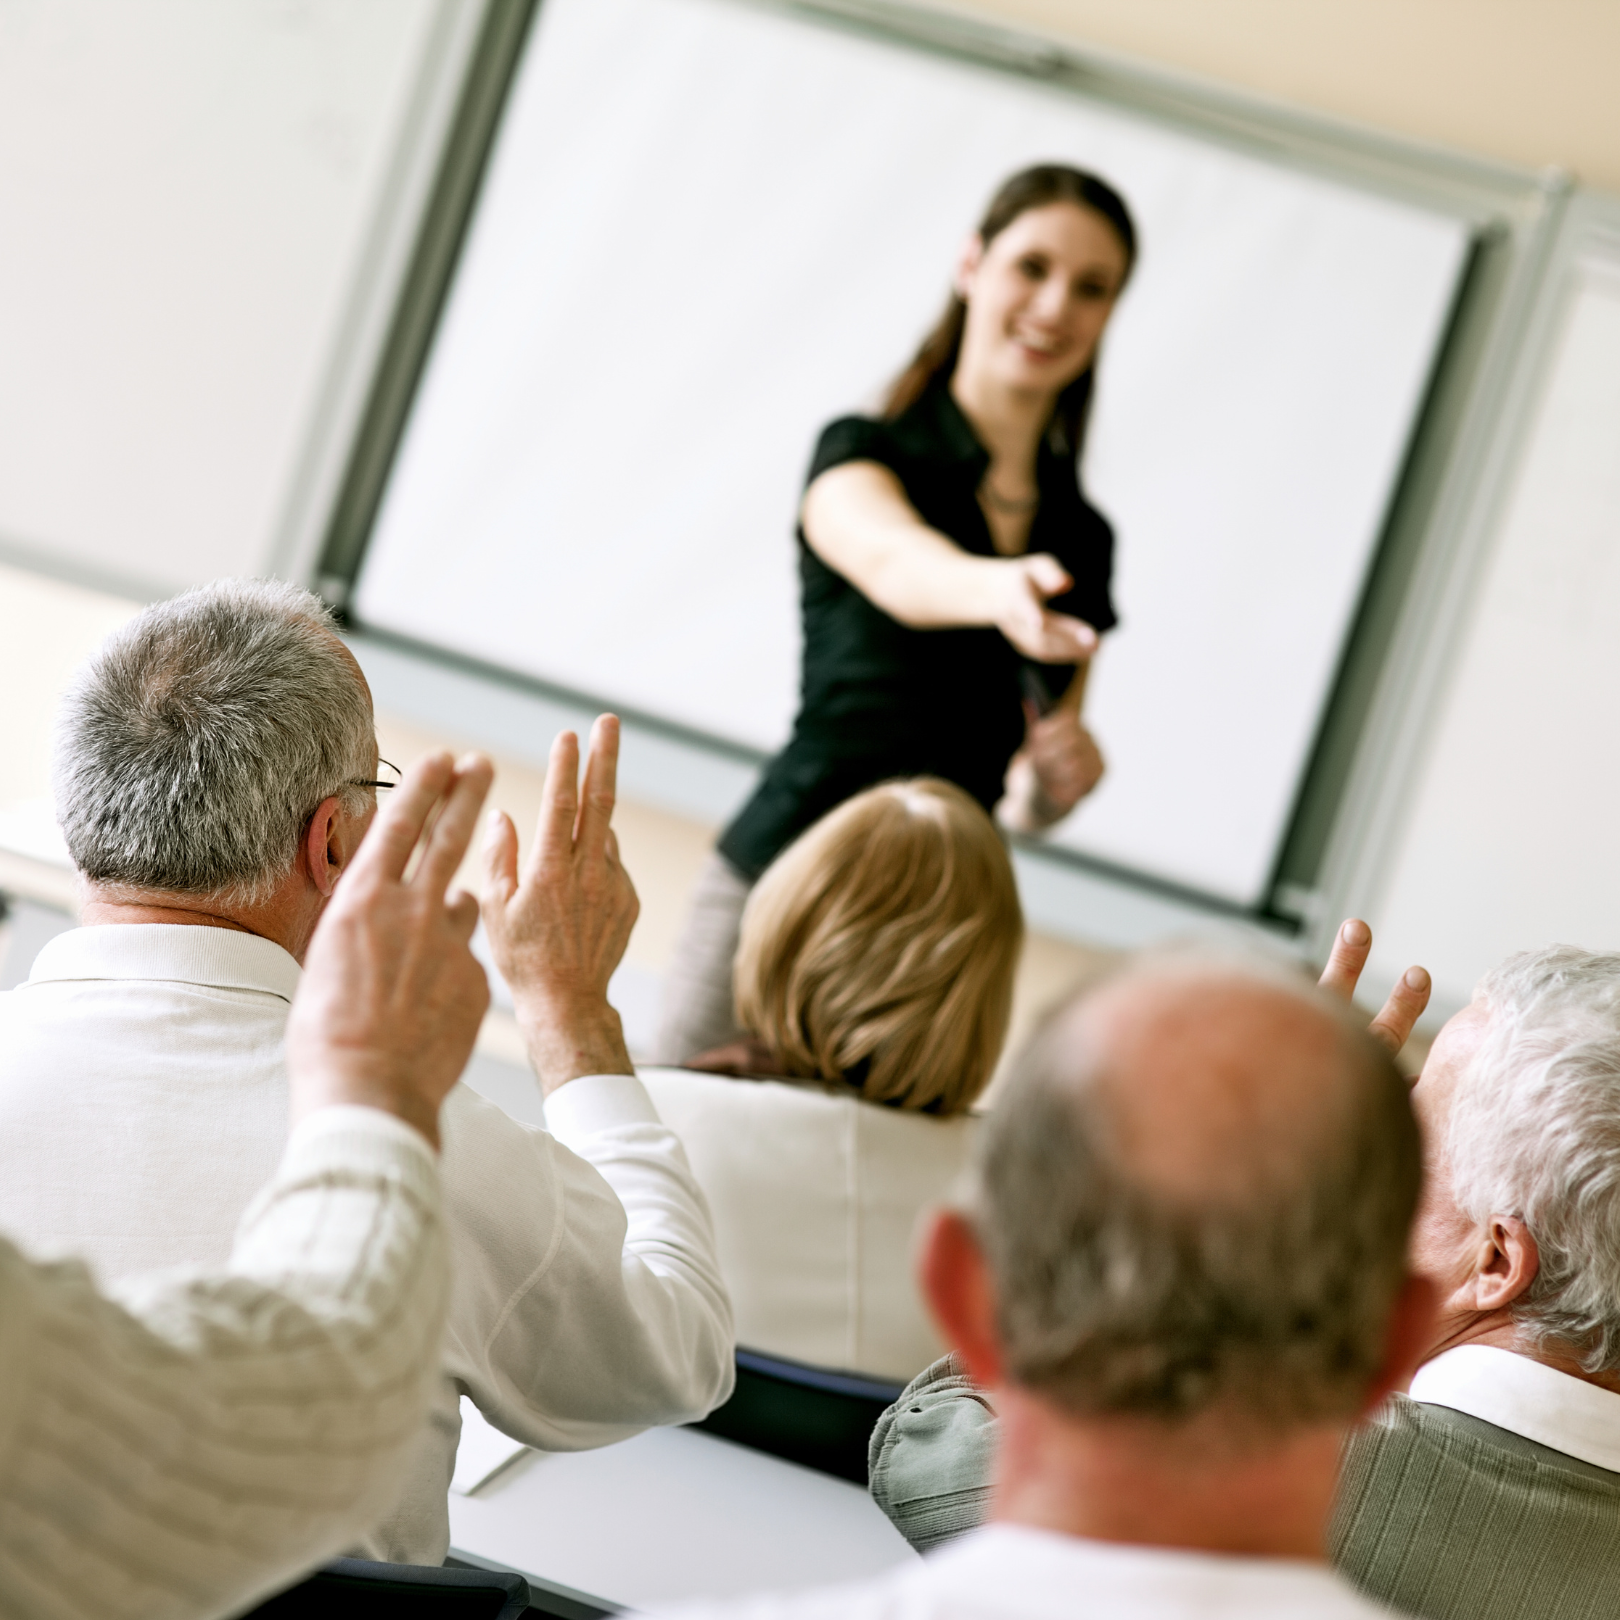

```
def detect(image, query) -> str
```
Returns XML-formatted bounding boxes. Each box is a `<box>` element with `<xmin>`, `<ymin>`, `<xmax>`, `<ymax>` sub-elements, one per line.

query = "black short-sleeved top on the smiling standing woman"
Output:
<box><xmin>719</xmin><ymin>381</ymin><xmax>1118</xmax><ymax>878</ymax></box>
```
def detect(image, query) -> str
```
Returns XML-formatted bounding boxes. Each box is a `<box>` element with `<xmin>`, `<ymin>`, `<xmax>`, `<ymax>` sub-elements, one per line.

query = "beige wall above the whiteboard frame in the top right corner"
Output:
<box><xmin>953</xmin><ymin>0</ymin><xmax>1620</xmax><ymax>193</ymax></box>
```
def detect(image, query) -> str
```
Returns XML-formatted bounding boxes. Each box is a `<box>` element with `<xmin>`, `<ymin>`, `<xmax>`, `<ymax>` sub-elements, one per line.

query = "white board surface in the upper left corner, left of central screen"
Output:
<box><xmin>0</xmin><ymin>0</ymin><xmax>446</xmax><ymax>595</ymax></box>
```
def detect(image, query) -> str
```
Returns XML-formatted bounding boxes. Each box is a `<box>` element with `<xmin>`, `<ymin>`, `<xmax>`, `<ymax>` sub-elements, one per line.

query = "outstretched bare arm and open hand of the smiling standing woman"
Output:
<box><xmin>800</xmin><ymin>462</ymin><xmax>1097</xmax><ymax>664</ymax></box>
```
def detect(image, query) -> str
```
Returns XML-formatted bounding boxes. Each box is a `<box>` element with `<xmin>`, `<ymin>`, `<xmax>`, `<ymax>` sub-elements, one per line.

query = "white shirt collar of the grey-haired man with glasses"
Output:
<box><xmin>28</xmin><ymin>922</ymin><xmax>301</xmax><ymax>1001</ymax></box>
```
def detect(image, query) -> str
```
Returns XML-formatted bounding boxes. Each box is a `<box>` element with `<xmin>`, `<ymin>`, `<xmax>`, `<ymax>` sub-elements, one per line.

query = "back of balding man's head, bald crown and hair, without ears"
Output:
<box><xmin>972</xmin><ymin>957</ymin><xmax>1419</xmax><ymax>1424</ymax></box>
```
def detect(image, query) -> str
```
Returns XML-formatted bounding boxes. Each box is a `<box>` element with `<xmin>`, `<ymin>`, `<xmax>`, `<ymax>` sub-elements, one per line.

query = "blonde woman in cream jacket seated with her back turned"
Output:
<box><xmin>643</xmin><ymin>778</ymin><xmax>1024</xmax><ymax>1382</ymax></box>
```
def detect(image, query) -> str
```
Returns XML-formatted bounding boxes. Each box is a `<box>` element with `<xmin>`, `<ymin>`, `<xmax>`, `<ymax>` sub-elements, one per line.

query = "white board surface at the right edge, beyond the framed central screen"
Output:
<box><xmin>1372</xmin><ymin>241</ymin><xmax>1620</xmax><ymax>1006</ymax></box>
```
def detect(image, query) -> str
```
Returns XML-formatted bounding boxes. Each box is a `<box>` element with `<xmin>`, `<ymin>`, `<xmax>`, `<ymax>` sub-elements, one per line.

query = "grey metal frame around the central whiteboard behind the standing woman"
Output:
<box><xmin>312</xmin><ymin>0</ymin><xmax>1570</xmax><ymax>954</ymax></box>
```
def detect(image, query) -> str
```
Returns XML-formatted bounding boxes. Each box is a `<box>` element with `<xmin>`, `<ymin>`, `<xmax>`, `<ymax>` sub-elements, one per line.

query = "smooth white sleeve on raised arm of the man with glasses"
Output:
<box><xmin>444</xmin><ymin>1074</ymin><xmax>735</xmax><ymax>1452</ymax></box>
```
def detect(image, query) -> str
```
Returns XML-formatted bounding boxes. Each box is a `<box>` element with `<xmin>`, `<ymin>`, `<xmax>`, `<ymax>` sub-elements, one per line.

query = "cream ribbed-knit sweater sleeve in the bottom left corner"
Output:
<box><xmin>0</xmin><ymin>1108</ymin><xmax>447</xmax><ymax>1620</ymax></box>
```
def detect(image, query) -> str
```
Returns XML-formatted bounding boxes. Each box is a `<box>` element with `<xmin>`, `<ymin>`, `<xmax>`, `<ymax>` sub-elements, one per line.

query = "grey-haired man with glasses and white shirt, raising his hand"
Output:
<box><xmin>0</xmin><ymin>582</ymin><xmax>732</xmax><ymax>1563</ymax></box>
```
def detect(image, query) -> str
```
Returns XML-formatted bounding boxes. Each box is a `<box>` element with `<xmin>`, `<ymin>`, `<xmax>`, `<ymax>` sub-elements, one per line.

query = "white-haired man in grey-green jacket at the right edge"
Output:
<box><xmin>873</xmin><ymin>946</ymin><xmax>1620</xmax><ymax>1620</ymax></box>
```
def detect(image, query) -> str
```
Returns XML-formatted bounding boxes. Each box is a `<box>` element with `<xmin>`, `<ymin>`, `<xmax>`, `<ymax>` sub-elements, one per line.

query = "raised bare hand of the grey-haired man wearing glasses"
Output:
<box><xmin>483</xmin><ymin>714</ymin><xmax>640</xmax><ymax>1094</ymax></box>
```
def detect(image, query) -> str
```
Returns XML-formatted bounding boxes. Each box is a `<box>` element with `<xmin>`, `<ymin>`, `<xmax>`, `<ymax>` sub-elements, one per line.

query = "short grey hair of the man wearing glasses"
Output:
<box><xmin>53</xmin><ymin>580</ymin><xmax>376</xmax><ymax>902</ymax></box>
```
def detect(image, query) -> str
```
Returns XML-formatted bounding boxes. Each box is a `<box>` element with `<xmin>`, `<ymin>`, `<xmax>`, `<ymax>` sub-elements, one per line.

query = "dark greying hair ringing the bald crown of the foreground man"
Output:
<box><xmin>967</xmin><ymin>962</ymin><xmax>1422</xmax><ymax>1430</ymax></box>
